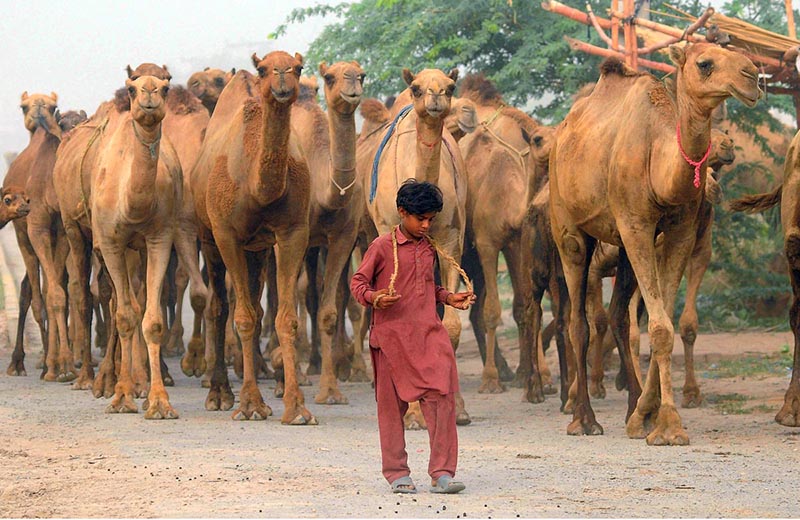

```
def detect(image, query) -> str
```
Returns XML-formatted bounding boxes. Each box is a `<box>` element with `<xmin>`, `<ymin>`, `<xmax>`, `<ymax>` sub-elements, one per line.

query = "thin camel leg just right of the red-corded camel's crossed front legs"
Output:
<box><xmin>678</xmin><ymin>221</ymin><xmax>714</xmax><ymax>408</ymax></box>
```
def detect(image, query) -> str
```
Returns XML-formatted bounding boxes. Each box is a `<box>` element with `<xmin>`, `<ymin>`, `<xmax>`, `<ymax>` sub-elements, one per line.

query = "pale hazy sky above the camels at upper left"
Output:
<box><xmin>0</xmin><ymin>0</ymin><xmax>333</xmax><ymax>176</ymax></box>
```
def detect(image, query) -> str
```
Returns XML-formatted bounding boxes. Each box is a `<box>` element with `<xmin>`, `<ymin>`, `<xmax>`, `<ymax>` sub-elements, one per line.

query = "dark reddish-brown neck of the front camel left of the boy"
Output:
<box><xmin>251</xmin><ymin>100</ymin><xmax>291</xmax><ymax>206</ymax></box>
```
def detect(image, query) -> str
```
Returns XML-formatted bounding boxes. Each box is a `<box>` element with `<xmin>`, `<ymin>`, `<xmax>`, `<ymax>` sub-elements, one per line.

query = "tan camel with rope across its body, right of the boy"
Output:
<box><xmin>459</xmin><ymin>74</ymin><xmax>545</xmax><ymax>393</ymax></box>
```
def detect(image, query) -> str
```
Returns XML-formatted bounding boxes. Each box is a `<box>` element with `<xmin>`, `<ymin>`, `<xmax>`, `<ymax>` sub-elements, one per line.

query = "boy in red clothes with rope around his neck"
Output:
<box><xmin>350</xmin><ymin>179</ymin><xmax>475</xmax><ymax>493</ymax></box>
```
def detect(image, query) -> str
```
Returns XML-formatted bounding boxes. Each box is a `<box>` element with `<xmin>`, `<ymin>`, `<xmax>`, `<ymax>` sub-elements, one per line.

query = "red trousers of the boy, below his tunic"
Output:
<box><xmin>369</xmin><ymin>348</ymin><xmax>458</xmax><ymax>483</ymax></box>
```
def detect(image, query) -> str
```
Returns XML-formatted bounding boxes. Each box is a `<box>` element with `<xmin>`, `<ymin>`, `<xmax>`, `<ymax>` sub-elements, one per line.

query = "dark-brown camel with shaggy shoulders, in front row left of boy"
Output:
<box><xmin>191</xmin><ymin>51</ymin><xmax>316</xmax><ymax>424</ymax></box>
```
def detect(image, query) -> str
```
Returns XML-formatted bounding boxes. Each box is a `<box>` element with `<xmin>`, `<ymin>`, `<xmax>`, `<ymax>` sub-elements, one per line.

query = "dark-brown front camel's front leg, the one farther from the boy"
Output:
<box><xmin>214</xmin><ymin>234</ymin><xmax>272</xmax><ymax>421</ymax></box>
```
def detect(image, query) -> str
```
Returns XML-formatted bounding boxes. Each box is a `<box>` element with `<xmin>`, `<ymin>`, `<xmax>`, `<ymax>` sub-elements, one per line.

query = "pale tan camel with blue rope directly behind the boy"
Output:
<box><xmin>356</xmin><ymin>69</ymin><xmax>470</xmax><ymax>426</ymax></box>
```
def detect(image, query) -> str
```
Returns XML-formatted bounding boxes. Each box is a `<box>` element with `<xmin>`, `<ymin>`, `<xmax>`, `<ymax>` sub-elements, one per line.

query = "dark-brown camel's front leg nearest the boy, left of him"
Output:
<box><xmin>275</xmin><ymin>226</ymin><xmax>317</xmax><ymax>425</ymax></box>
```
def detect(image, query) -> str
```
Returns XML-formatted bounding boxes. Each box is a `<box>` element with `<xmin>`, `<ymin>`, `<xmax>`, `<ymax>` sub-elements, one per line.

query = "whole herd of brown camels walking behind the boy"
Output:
<box><xmin>0</xmin><ymin>44</ymin><xmax>800</xmax><ymax>445</ymax></box>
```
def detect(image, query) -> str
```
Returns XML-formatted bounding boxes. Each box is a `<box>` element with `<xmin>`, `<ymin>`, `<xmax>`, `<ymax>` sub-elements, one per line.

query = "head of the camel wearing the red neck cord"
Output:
<box><xmin>669</xmin><ymin>43</ymin><xmax>762</xmax><ymax>114</ymax></box>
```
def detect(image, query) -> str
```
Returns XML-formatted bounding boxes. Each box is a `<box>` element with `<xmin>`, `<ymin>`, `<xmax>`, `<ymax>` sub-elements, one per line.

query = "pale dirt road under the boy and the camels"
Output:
<box><xmin>0</xmin><ymin>228</ymin><xmax>800</xmax><ymax>518</ymax></box>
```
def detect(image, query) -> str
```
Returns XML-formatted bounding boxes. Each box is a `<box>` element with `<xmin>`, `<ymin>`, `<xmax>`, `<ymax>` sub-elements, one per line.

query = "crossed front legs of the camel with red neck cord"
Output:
<box><xmin>619</xmin><ymin>225</ymin><xmax>694</xmax><ymax>445</ymax></box>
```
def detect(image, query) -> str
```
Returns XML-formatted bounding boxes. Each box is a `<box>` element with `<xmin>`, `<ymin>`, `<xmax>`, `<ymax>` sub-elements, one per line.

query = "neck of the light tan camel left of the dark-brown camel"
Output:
<box><xmin>123</xmin><ymin>119</ymin><xmax>161</xmax><ymax>222</ymax></box>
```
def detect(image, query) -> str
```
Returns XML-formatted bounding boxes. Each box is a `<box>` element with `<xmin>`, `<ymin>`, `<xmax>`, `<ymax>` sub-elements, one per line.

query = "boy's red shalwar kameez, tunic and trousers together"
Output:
<box><xmin>350</xmin><ymin>229</ymin><xmax>458</xmax><ymax>483</ymax></box>
